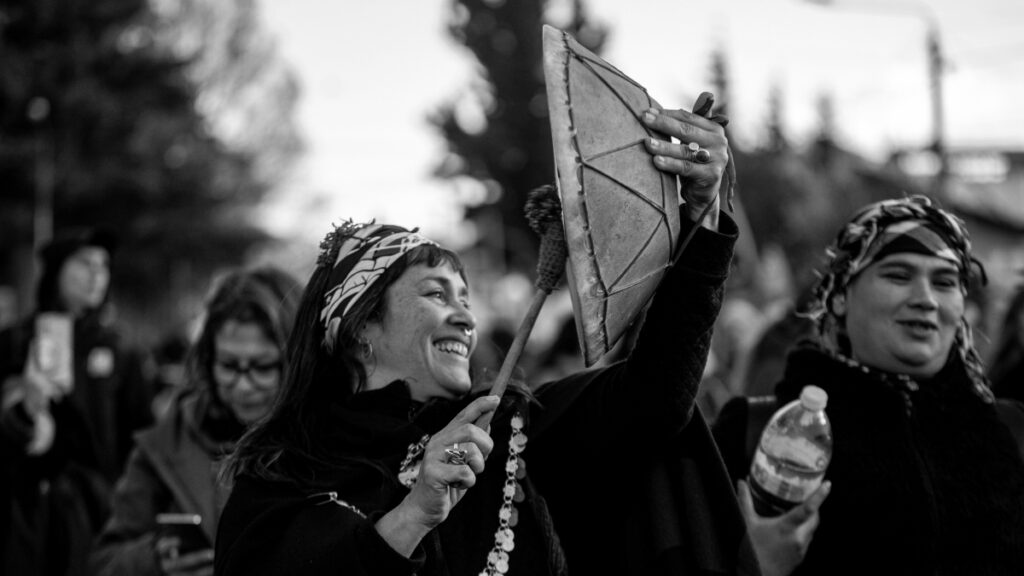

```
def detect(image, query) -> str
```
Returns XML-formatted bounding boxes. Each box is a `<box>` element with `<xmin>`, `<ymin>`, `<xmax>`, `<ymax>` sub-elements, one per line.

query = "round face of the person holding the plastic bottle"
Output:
<box><xmin>836</xmin><ymin>252</ymin><xmax>965</xmax><ymax>378</ymax></box>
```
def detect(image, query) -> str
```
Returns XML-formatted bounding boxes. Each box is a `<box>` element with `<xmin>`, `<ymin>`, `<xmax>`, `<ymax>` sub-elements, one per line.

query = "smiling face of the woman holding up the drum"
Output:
<box><xmin>362</xmin><ymin>263</ymin><xmax>476</xmax><ymax>401</ymax></box>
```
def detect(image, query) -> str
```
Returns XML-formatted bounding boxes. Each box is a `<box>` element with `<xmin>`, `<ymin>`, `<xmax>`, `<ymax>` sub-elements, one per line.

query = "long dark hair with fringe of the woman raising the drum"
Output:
<box><xmin>225</xmin><ymin>244</ymin><xmax>466</xmax><ymax>482</ymax></box>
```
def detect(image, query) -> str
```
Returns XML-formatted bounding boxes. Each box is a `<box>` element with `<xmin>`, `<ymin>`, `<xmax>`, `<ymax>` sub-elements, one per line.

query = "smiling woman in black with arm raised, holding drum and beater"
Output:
<box><xmin>216</xmin><ymin>99</ymin><xmax>757</xmax><ymax>576</ymax></box>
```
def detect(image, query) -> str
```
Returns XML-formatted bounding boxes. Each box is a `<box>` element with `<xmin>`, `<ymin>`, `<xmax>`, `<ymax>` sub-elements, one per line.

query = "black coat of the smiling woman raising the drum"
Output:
<box><xmin>216</xmin><ymin>217</ymin><xmax>757</xmax><ymax>576</ymax></box>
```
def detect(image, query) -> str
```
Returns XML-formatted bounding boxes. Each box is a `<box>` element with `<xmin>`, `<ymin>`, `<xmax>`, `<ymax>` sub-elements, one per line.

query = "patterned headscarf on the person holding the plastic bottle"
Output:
<box><xmin>806</xmin><ymin>196</ymin><xmax>991</xmax><ymax>399</ymax></box>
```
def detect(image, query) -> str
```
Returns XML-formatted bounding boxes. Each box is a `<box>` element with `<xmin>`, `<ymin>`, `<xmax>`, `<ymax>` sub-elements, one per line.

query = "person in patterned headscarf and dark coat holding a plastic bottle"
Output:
<box><xmin>716</xmin><ymin>197</ymin><xmax>1024</xmax><ymax>575</ymax></box>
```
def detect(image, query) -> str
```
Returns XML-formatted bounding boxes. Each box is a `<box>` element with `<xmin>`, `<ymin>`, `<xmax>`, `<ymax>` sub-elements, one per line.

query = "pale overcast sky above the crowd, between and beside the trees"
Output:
<box><xmin>261</xmin><ymin>0</ymin><xmax>1024</xmax><ymax>245</ymax></box>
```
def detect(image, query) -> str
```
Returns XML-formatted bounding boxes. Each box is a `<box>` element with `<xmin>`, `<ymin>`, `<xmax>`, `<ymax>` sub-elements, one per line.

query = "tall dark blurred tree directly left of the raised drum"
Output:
<box><xmin>430</xmin><ymin>0</ymin><xmax>606</xmax><ymax>274</ymax></box>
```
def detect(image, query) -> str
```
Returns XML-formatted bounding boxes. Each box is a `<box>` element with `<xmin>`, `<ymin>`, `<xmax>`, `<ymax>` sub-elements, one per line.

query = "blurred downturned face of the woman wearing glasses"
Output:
<box><xmin>212</xmin><ymin>320</ymin><xmax>282</xmax><ymax>424</ymax></box>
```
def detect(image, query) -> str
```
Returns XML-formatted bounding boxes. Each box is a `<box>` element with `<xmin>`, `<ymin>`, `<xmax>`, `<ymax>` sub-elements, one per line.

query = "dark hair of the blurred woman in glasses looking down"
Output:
<box><xmin>185</xmin><ymin>266</ymin><xmax>302</xmax><ymax>404</ymax></box>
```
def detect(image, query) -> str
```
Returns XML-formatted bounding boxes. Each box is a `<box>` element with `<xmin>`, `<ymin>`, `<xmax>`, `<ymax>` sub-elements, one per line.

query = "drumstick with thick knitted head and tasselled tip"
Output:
<box><xmin>476</xmin><ymin>184</ymin><xmax>568</xmax><ymax>429</ymax></box>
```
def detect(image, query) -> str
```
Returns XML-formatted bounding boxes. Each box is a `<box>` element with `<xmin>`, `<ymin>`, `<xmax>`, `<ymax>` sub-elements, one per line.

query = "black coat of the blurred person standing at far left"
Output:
<box><xmin>0</xmin><ymin>315</ymin><xmax>153</xmax><ymax>574</ymax></box>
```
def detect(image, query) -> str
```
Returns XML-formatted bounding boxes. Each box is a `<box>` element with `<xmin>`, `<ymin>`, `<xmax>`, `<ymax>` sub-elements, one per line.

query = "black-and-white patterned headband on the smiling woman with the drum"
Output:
<box><xmin>317</xmin><ymin>220</ymin><xmax>437</xmax><ymax>353</ymax></box>
